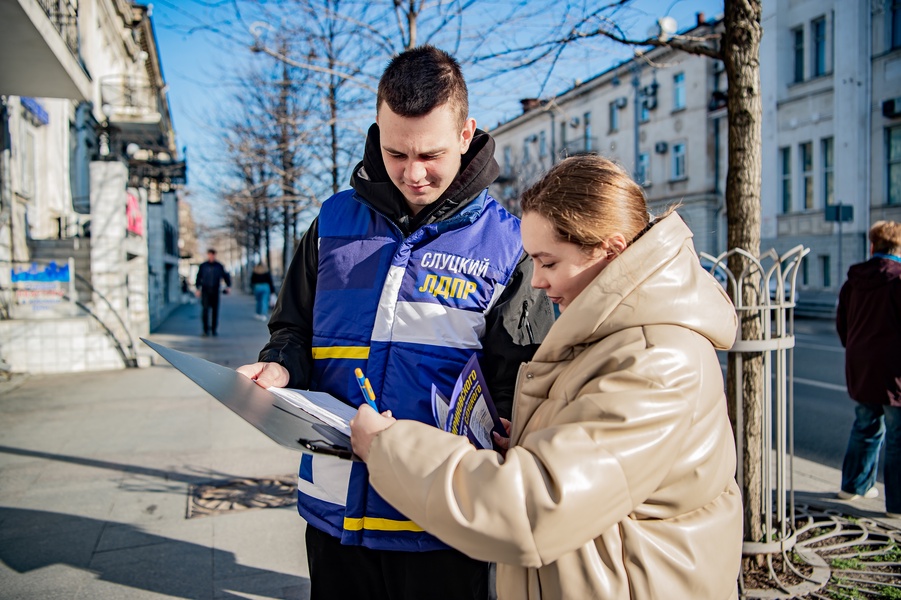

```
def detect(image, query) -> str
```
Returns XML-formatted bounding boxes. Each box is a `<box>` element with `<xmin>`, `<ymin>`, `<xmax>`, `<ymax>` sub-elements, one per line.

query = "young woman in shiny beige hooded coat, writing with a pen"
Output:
<box><xmin>351</xmin><ymin>156</ymin><xmax>742</xmax><ymax>600</ymax></box>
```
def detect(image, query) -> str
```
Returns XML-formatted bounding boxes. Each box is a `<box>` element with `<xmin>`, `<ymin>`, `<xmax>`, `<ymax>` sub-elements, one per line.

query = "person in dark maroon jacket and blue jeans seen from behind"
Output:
<box><xmin>836</xmin><ymin>221</ymin><xmax>901</xmax><ymax>518</ymax></box>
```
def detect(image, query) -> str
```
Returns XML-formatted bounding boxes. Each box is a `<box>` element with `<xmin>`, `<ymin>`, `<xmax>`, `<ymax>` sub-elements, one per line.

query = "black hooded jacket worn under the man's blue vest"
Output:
<box><xmin>259</xmin><ymin>125</ymin><xmax>554</xmax><ymax>418</ymax></box>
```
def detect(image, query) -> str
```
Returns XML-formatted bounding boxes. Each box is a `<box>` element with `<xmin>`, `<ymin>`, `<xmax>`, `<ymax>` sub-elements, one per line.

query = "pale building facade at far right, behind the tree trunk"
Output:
<box><xmin>761</xmin><ymin>0</ymin><xmax>901</xmax><ymax>300</ymax></box>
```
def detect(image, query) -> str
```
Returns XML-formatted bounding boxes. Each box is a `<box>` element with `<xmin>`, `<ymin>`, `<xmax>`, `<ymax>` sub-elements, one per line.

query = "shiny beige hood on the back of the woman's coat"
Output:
<box><xmin>535</xmin><ymin>213</ymin><xmax>738</xmax><ymax>361</ymax></box>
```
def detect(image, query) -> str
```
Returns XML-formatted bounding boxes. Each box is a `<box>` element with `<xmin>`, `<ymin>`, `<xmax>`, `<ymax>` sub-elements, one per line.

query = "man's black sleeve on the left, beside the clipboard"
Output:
<box><xmin>259</xmin><ymin>219</ymin><xmax>319</xmax><ymax>389</ymax></box>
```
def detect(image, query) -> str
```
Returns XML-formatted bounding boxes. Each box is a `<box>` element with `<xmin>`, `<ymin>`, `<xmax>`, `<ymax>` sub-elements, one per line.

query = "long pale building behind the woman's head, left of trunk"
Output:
<box><xmin>491</xmin><ymin>14</ymin><xmax>727</xmax><ymax>254</ymax></box>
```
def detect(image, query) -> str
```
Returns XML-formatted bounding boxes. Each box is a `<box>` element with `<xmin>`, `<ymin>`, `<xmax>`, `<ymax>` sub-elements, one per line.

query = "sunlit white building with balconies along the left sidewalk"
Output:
<box><xmin>0</xmin><ymin>0</ymin><xmax>186</xmax><ymax>373</ymax></box>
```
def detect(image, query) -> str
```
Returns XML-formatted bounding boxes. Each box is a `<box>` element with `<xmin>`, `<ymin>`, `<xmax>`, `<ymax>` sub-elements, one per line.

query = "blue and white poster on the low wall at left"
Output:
<box><xmin>11</xmin><ymin>261</ymin><xmax>75</xmax><ymax>319</ymax></box>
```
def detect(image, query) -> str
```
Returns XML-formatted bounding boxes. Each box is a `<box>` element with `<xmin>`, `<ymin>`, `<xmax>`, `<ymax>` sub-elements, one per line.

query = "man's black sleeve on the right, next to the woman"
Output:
<box><xmin>481</xmin><ymin>253</ymin><xmax>554</xmax><ymax>419</ymax></box>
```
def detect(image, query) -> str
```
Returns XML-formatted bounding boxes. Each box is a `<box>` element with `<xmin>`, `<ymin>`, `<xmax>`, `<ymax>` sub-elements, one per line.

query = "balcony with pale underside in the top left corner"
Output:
<box><xmin>0</xmin><ymin>0</ymin><xmax>91</xmax><ymax>100</ymax></box>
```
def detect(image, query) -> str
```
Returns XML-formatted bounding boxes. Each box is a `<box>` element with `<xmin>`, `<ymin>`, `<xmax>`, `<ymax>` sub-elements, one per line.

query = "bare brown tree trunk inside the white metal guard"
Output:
<box><xmin>722</xmin><ymin>0</ymin><xmax>764</xmax><ymax>552</ymax></box>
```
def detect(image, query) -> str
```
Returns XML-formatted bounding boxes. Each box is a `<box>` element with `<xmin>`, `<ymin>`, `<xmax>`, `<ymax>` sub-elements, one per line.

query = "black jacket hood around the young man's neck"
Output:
<box><xmin>350</xmin><ymin>123</ymin><xmax>500</xmax><ymax>232</ymax></box>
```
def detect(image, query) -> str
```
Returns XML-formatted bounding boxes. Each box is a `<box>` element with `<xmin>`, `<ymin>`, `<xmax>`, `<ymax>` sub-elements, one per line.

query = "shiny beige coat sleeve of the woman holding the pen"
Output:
<box><xmin>367</xmin><ymin>346</ymin><xmax>697</xmax><ymax>568</ymax></box>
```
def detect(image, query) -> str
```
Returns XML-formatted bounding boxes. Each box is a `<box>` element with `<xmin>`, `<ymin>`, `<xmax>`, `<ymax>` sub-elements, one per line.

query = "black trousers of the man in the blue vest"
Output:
<box><xmin>307</xmin><ymin>524</ymin><xmax>488</xmax><ymax>600</ymax></box>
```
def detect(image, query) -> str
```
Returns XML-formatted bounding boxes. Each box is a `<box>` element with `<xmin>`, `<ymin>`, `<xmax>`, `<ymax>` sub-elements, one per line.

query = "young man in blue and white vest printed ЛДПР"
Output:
<box><xmin>238</xmin><ymin>46</ymin><xmax>553</xmax><ymax>600</ymax></box>
